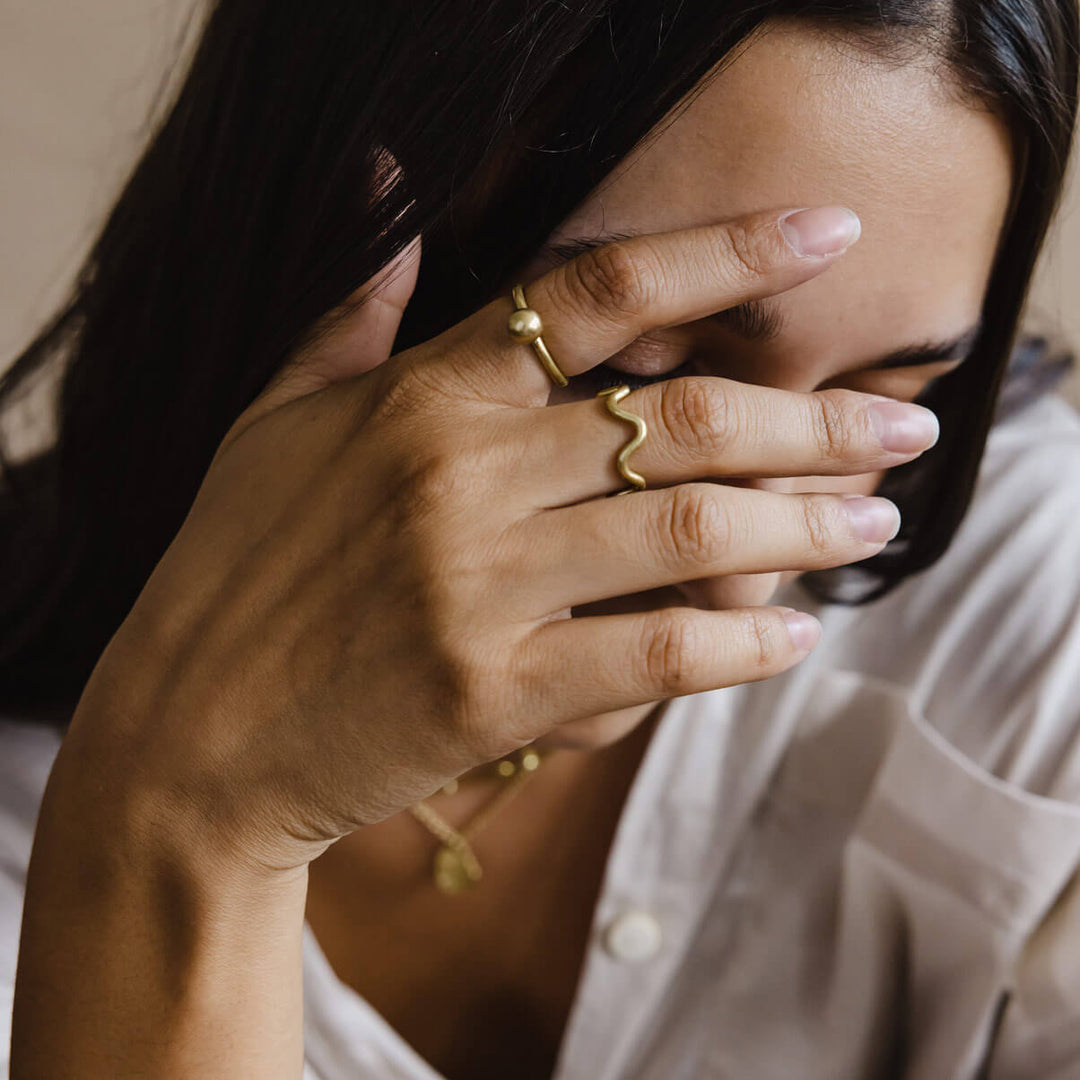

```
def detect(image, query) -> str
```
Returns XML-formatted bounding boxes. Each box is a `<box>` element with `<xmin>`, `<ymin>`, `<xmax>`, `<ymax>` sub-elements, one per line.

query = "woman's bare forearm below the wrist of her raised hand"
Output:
<box><xmin>11</xmin><ymin>721</ymin><xmax>307</xmax><ymax>1080</ymax></box>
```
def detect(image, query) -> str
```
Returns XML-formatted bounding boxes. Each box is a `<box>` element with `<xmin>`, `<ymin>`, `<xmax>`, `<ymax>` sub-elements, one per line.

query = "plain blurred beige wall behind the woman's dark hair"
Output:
<box><xmin>0</xmin><ymin>0</ymin><xmax>1080</xmax><ymax>438</ymax></box>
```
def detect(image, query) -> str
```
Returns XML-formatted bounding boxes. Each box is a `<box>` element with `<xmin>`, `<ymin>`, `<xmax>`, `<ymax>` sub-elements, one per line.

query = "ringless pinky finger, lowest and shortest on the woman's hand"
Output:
<box><xmin>518</xmin><ymin>607</ymin><xmax>821</xmax><ymax>725</ymax></box>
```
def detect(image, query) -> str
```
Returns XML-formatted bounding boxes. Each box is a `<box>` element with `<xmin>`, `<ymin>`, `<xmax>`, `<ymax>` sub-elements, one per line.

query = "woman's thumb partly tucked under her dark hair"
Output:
<box><xmin>243</xmin><ymin>235</ymin><xmax>420</xmax><ymax>427</ymax></box>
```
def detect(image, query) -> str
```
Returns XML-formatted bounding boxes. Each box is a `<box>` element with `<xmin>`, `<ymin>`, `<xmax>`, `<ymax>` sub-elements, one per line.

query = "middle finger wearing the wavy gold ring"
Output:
<box><xmin>507</xmin><ymin>376</ymin><xmax>939</xmax><ymax>510</ymax></box>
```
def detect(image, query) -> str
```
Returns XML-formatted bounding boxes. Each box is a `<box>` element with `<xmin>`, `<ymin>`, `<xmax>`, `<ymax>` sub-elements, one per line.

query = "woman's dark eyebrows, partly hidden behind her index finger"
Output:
<box><xmin>544</xmin><ymin>232</ymin><xmax>980</xmax><ymax>372</ymax></box>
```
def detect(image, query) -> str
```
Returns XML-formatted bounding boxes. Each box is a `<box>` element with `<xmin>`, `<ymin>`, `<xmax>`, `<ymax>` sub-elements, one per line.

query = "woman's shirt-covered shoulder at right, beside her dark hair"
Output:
<box><xmin>829</xmin><ymin>395</ymin><xmax>1080</xmax><ymax>802</ymax></box>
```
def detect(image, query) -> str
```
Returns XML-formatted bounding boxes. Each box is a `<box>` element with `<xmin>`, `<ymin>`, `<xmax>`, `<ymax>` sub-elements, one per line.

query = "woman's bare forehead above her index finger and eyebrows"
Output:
<box><xmin>554</xmin><ymin>23</ymin><xmax>1012</xmax><ymax>374</ymax></box>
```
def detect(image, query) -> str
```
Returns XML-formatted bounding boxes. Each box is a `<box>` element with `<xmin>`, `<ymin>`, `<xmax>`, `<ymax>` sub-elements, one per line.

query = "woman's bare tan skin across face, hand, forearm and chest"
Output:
<box><xmin>12</xmin><ymin>16</ymin><xmax>1011</xmax><ymax>1080</ymax></box>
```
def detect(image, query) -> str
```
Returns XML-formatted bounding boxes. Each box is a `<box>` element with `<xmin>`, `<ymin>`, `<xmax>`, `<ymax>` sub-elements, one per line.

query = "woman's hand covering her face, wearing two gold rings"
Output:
<box><xmin>68</xmin><ymin>206</ymin><xmax>937</xmax><ymax>868</ymax></box>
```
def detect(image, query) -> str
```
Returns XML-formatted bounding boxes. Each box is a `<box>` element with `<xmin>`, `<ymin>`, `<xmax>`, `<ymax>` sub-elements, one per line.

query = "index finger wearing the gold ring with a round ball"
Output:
<box><xmin>428</xmin><ymin>206</ymin><xmax>861</xmax><ymax>406</ymax></box>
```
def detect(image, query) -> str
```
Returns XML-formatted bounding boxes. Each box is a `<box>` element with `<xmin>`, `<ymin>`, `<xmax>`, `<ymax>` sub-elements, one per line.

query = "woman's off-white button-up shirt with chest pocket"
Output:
<box><xmin>0</xmin><ymin>396</ymin><xmax>1080</xmax><ymax>1080</ymax></box>
